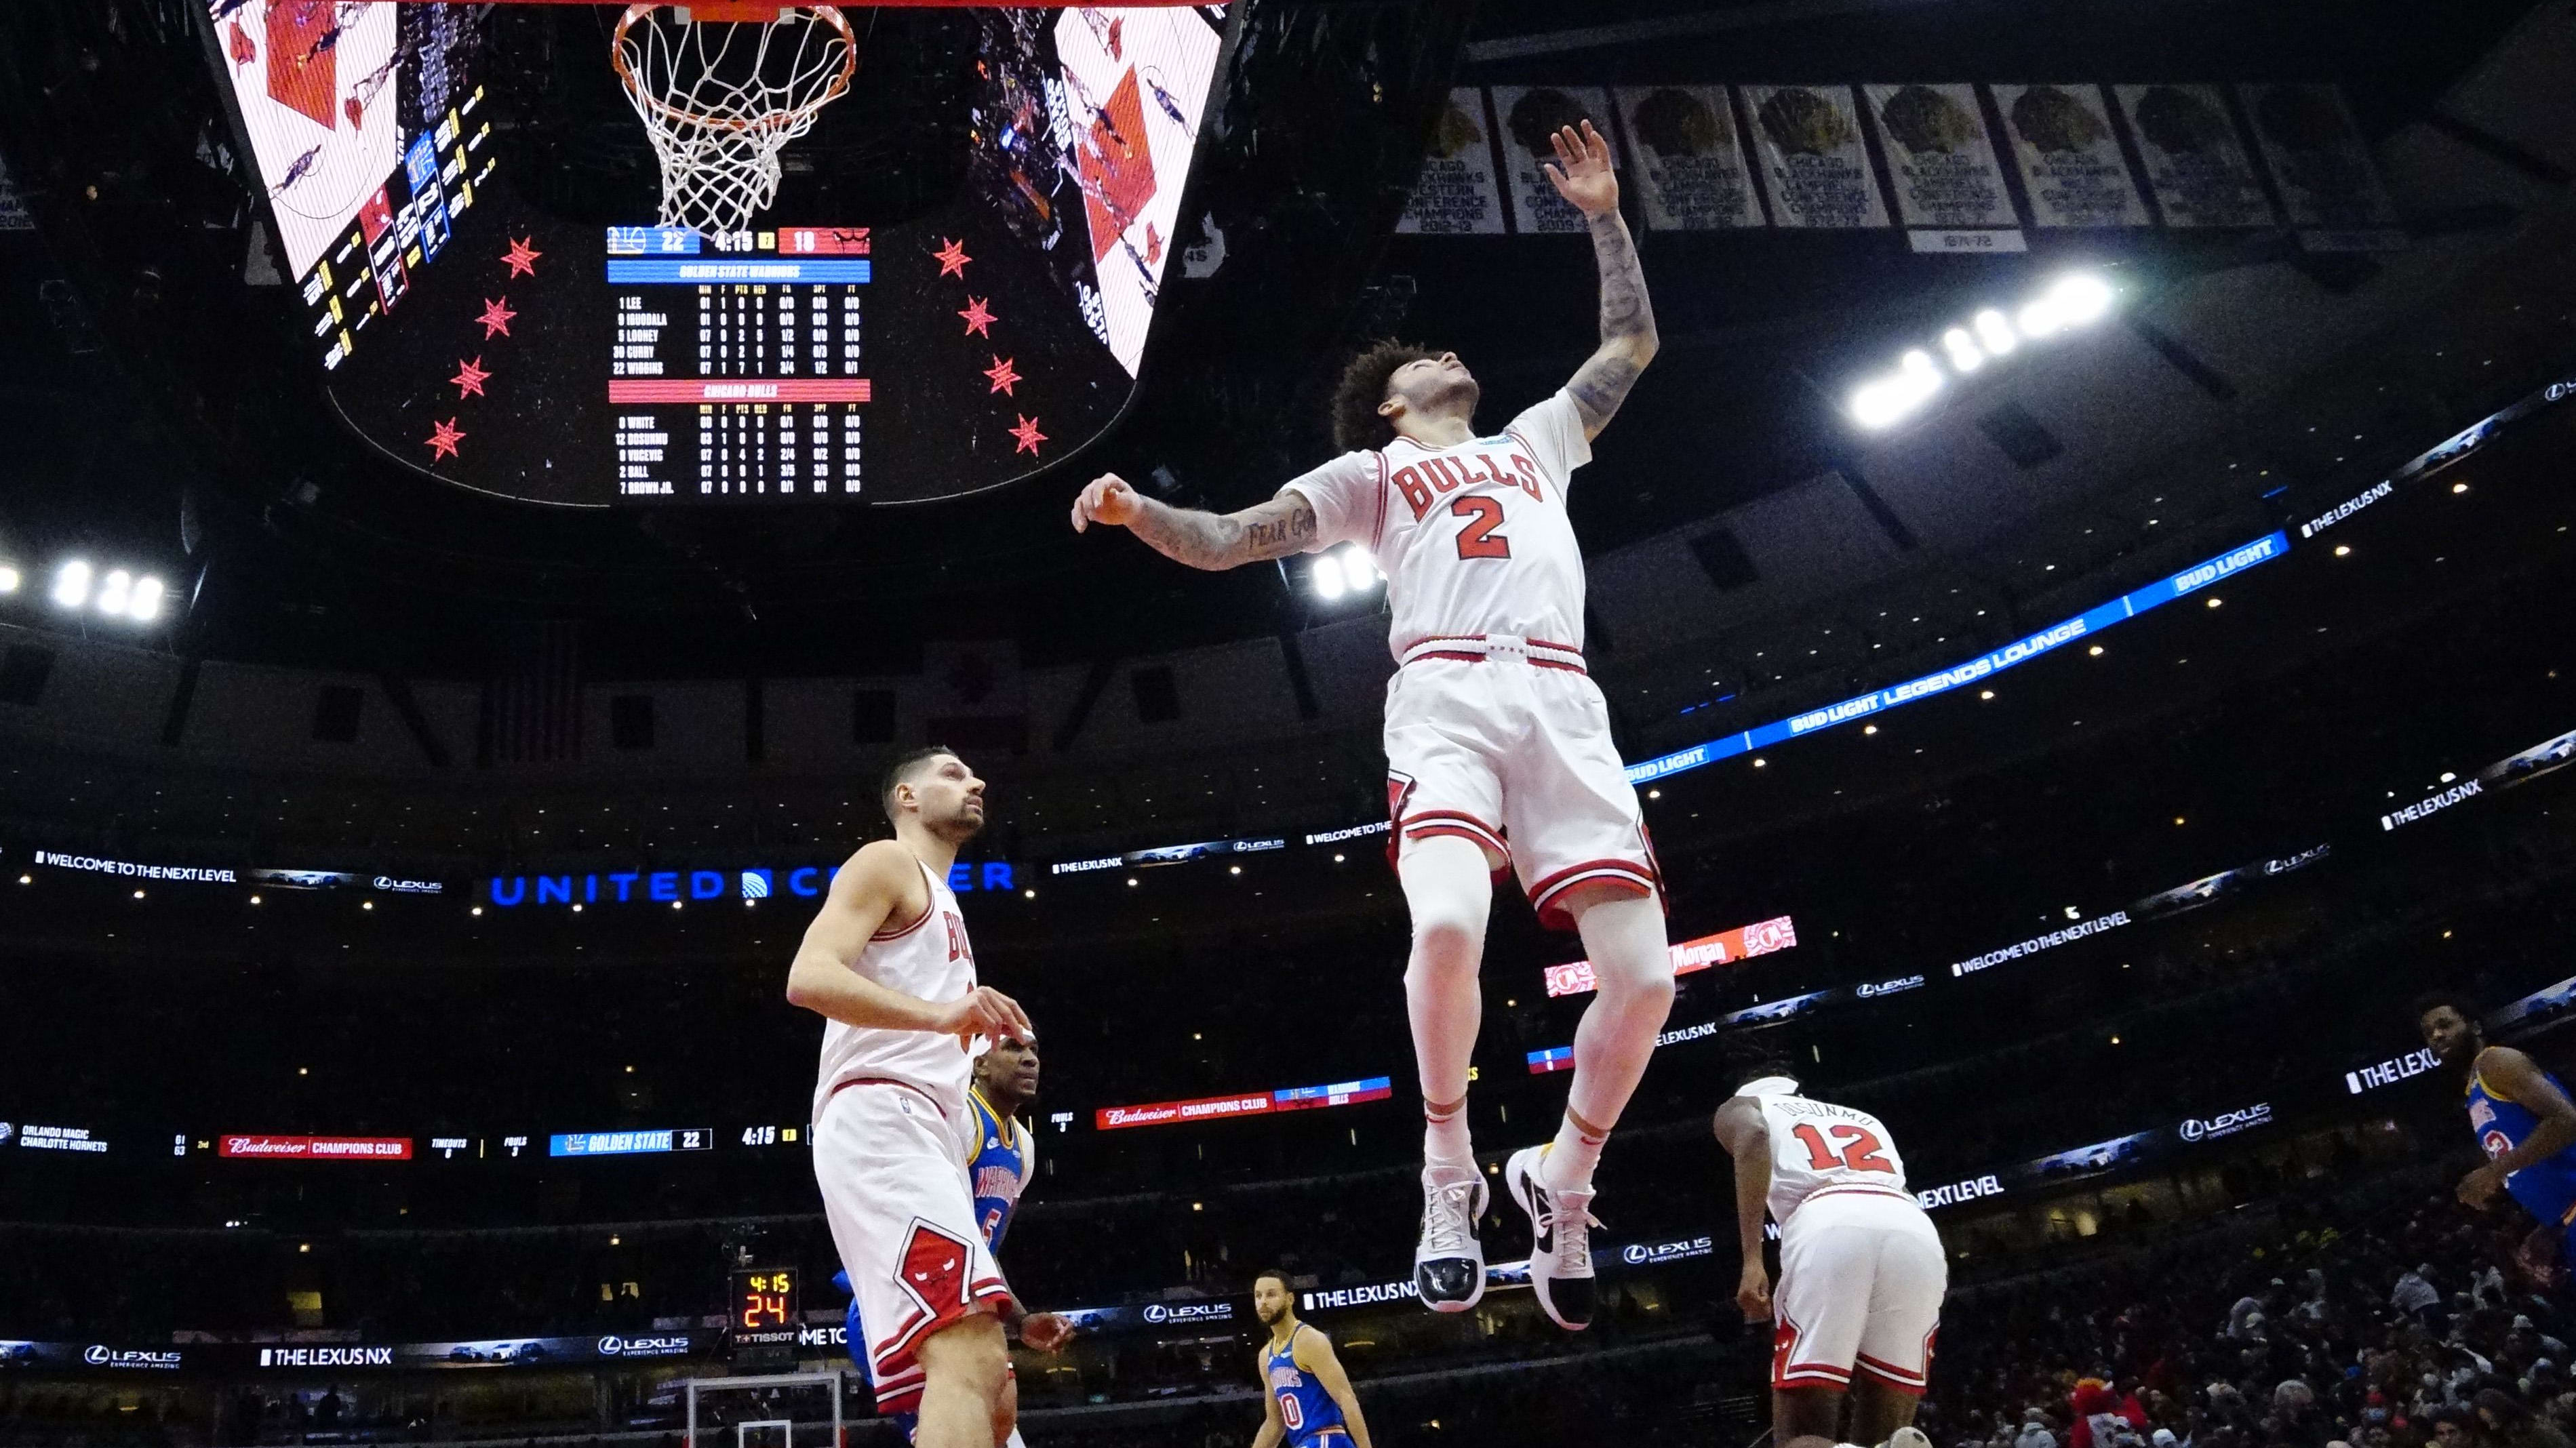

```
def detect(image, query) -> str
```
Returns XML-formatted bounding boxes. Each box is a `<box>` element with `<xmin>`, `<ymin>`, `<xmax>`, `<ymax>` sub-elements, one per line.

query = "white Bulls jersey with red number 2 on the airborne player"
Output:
<box><xmin>1286</xmin><ymin>392</ymin><xmax>1592</xmax><ymax>660</ymax></box>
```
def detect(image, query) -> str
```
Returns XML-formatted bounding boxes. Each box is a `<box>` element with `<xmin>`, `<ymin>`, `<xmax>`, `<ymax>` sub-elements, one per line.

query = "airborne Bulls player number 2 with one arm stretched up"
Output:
<box><xmin>1074</xmin><ymin>121</ymin><xmax>1672</xmax><ymax>1327</ymax></box>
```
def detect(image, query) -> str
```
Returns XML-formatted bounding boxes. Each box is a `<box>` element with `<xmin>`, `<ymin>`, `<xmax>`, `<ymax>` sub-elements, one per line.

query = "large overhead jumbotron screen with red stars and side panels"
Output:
<box><xmin>209</xmin><ymin>0</ymin><xmax>1224</xmax><ymax>508</ymax></box>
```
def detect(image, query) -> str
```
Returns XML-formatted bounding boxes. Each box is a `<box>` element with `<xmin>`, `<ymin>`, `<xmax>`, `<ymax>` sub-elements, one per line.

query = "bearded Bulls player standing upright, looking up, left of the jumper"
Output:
<box><xmin>788</xmin><ymin>747</ymin><xmax>1035</xmax><ymax>1448</ymax></box>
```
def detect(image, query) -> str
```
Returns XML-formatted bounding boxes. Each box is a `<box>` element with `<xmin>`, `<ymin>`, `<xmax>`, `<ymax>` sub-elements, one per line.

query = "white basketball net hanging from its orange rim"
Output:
<box><xmin>616</xmin><ymin>3</ymin><xmax>858</xmax><ymax>235</ymax></box>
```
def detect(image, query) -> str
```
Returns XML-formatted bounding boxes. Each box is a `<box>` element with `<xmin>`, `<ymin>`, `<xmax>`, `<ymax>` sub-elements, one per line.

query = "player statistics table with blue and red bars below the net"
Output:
<box><xmin>608</xmin><ymin>226</ymin><xmax>873</xmax><ymax>502</ymax></box>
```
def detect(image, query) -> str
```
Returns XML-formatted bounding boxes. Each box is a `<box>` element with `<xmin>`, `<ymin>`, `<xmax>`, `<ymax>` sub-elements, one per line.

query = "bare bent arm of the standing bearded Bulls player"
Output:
<box><xmin>788</xmin><ymin>840</ymin><xmax>1033</xmax><ymax>1039</ymax></box>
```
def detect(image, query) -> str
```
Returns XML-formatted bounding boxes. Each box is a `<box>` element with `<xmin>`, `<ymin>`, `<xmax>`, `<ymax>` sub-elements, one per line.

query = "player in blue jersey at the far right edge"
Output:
<box><xmin>2416</xmin><ymin>992</ymin><xmax>2576</xmax><ymax>1265</ymax></box>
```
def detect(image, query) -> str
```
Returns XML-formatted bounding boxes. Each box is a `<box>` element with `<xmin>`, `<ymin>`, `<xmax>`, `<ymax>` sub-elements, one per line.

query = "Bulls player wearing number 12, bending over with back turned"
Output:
<box><xmin>1716</xmin><ymin>1062</ymin><xmax>1950</xmax><ymax>1448</ymax></box>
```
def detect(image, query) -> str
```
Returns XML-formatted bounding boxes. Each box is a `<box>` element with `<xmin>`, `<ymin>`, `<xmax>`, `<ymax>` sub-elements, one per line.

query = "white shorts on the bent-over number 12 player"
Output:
<box><xmin>1772</xmin><ymin>1188</ymin><xmax>1950</xmax><ymax>1394</ymax></box>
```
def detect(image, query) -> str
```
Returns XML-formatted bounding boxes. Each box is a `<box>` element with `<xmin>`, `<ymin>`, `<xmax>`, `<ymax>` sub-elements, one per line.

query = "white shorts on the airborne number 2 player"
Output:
<box><xmin>1386</xmin><ymin>639</ymin><xmax>1664</xmax><ymax>930</ymax></box>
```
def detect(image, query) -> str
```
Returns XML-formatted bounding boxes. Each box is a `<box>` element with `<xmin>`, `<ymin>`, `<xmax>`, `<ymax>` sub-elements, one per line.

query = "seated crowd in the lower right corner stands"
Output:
<box><xmin>1922</xmin><ymin>1159</ymin><xmax>2576</xmax><ymax>1448</ymax></box>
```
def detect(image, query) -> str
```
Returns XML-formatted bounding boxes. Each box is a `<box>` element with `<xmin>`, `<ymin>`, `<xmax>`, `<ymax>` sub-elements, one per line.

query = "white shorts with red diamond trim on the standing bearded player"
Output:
<box><xmin>814</xmin><ymin>1079</ymin><xmax>1010</xmax><ymax>1412</ymax></box>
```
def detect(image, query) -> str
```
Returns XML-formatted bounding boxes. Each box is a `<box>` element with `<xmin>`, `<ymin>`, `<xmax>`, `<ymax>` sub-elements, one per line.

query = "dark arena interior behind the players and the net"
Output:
<box><xmin>0</xmin><ymin>0</ymin><xmax>2576</xmax><ymax>1448</ymax></box>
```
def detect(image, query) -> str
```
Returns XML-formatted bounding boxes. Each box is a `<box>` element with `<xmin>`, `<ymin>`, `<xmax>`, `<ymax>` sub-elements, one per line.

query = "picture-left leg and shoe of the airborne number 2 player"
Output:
<box><xmin>1396</xmin><ymin>834</ymin><xmax>1494</xmax><ymax>1312</ymax></box>
